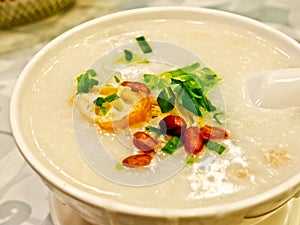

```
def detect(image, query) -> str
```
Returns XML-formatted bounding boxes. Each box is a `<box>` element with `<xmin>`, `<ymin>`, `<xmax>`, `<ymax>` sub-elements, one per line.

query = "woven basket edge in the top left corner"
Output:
<box><xmin>0</xmin><ymin>0</ymin><xmax>75</xmax><ymax>28</ymax></box>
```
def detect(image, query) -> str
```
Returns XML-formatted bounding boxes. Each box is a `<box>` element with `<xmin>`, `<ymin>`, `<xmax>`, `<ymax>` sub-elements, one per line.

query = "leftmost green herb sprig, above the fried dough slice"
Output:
<box><xmin>76</xmin><ymin>69</ymin><xmax>99</xmax><ymax>94</ymax></box>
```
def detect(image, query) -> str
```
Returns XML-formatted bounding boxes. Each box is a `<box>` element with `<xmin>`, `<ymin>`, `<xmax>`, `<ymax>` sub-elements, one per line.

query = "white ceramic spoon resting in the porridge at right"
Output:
<box><xmin>246</xmin><ymin>68</ymin><xmax>300</xmax><ymax>109</ymax></box>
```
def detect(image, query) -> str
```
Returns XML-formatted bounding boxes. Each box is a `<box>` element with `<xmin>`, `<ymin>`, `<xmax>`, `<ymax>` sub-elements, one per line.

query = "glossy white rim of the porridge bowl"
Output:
<box><xmin>10</xmin><ymin>6</ymin><xmax>300</xmax><ymax>218</ymax></box>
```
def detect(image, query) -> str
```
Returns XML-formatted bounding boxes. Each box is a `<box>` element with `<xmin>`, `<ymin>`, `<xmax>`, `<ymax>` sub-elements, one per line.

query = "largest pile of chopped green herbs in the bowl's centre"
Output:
<box><xmin>144</xmin><ymin>63</ymin><xmax>221</xmax><ymax>116</ymax></box>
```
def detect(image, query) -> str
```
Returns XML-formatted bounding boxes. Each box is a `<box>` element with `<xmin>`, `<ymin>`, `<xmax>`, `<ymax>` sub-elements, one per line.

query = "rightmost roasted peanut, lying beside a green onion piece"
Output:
<box><xmin>200</xmin><ymin>125</ymin><xmax>229</xmax><ymax>141</ymax></box>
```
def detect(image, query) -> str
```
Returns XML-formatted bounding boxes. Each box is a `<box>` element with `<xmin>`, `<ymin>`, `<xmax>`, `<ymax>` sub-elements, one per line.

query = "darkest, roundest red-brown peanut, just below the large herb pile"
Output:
<box><xmin>159</xmin><ymin>115</ymin><xmax>186</xmax><ymax>136</ymax></box>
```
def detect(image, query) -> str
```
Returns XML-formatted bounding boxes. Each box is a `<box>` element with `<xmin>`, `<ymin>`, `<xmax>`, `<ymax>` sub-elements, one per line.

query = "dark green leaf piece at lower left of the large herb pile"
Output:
<box><xmin>157</xmin><ymin>87</ymin><xmax>175</xmax><ymax>113</ymax></box>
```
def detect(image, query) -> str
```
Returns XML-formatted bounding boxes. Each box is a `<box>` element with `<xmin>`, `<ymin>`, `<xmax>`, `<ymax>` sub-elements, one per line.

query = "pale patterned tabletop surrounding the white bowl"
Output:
<box><xmin>0</xmin><ymin>0</ymin><xmax>300</xmax><ymax>225</ymax></box>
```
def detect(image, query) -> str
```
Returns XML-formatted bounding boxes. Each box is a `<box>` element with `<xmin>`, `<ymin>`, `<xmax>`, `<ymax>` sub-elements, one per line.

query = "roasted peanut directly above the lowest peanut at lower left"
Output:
<box><xmin>133</xmin><ymin>131</ymin><xmax>158</xmax><ymax>153</ymax></box>
